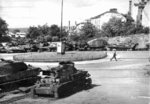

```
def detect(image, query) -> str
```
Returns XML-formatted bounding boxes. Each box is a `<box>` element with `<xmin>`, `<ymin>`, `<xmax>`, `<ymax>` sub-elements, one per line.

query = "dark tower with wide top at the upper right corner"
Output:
<box><xmin>134</xmin><ymin>0</ymin><xmax>149</xmax><ymax>26</ymax></box>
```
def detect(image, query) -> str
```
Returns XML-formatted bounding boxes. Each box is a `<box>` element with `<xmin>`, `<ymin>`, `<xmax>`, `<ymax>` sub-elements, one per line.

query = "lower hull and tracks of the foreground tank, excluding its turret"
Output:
<box><xmin>35</xmin><ymin>71</ymin><xmax>92</xmax><ymax>98</ymax></box>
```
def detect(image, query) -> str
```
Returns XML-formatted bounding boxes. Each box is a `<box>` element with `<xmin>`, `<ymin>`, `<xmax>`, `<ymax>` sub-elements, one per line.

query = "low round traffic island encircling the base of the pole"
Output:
<box><xmin>13</xmin><ymin>51</ymin><xmax>107</xmax><ymax>62</ymax></box>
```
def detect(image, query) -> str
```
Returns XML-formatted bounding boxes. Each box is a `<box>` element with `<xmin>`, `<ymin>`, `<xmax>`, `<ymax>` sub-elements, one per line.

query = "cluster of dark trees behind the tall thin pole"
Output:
<box><xmin>27</xmin><ymin>24</ymin><xmax>68</xmax><ymax>42</ymax></box>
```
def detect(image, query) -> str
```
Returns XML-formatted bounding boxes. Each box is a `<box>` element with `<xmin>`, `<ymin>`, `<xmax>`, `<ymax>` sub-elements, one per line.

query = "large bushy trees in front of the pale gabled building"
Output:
<box><xmin>101</xmin><ymin>17</ymin><xmax>149</xmax><ymax>37</ymax></box>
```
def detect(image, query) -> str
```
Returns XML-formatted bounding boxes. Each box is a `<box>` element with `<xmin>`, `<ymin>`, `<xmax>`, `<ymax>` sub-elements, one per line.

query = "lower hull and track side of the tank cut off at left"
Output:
<box><xmin>0</xmin><ymin>68</ymin><xmax>40</xmax><ymax>94</ymax></box>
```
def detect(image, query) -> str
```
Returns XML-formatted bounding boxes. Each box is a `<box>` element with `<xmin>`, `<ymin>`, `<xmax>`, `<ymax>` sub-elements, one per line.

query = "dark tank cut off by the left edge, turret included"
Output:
<box><xmin>0</xmin><ymin>59</ymin><xmax>41</xmax><ymax>94</ymax></box>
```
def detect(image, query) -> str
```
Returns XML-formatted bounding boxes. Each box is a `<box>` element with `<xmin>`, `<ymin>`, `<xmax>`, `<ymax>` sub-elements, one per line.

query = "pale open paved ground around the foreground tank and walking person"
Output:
<box><xmin>1</xmin><ymin>52</ymin><xmax>150</xmax><ymax>104</ymax></box>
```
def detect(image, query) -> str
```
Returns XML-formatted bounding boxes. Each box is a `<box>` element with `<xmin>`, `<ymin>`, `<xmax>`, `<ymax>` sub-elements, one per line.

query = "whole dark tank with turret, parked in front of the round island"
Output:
<box><xmin>34</xmin><ymin>61</ymin><xmax>92</xmax><ymax>98</ymax></box>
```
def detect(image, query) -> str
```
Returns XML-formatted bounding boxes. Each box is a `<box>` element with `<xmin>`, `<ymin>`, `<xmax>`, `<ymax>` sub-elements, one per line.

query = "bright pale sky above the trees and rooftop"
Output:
<box><xmin>0</xmin><ymin>0</ymin><xmax>141</xmax><ymax>27</ymax></box>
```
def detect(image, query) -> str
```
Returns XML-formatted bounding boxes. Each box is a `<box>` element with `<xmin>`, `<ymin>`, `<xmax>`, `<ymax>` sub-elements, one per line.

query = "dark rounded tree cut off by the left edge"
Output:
<box><xmin>0</xmin><ymin>18</ymin><xmax>8</xmax><ymax>38</ymax></box>
